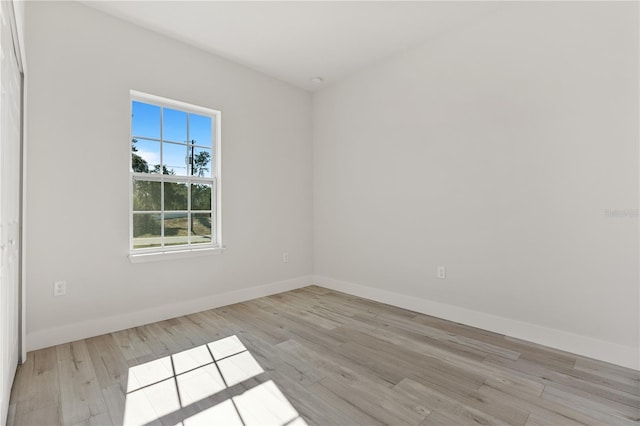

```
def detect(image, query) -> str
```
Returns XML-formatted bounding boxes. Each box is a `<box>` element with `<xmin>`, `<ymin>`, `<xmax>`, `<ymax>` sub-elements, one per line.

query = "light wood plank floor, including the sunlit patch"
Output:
<box><xmin>8</xmin><ymin>286</ymin><xmax>640</xmax><ymax>426</ymax></box>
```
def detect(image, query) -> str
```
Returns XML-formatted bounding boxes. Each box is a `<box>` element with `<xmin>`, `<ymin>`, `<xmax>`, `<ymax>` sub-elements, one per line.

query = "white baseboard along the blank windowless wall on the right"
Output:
<box><xmin>314</xmin><ymin>275</ymin><xmax>640</xmax><ymax>370</ymax></box>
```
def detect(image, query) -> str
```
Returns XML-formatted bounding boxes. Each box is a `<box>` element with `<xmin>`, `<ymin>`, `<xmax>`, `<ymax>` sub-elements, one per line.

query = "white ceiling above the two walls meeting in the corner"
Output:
<box><xmin>83</xmin><ymin>0</ymin><xmax>497</xmax><ymax>90</ymax></box>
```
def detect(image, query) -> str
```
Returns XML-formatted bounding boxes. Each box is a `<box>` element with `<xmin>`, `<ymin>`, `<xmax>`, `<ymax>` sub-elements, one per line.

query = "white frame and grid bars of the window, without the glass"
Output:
<box><xmin>128</xmin><ymin>90</ymin><xmax>224</xmax><ymax>263</ymax></box>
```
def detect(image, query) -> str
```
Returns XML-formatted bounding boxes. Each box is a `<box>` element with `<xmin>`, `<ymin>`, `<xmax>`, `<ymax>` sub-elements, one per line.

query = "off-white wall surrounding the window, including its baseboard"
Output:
<box><xmin>26</xmin><ymin>2</ymin><xmax>312</xmax><ymax>349</ymax></box>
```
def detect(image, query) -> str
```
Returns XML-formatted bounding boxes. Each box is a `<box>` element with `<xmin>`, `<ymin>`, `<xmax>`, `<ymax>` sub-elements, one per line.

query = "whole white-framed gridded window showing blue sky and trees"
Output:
<box><xmin>130</xmin><ymin>91</ymin><xmax>221</xmax><ymax>257</ymax></box>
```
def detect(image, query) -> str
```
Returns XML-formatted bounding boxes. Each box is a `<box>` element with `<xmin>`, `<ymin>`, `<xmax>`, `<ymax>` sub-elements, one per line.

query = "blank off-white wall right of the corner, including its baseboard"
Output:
<box><xmin>313</xmin><ymin>2</ymin><xmax>640</xmax><ymax>368</ymax></box>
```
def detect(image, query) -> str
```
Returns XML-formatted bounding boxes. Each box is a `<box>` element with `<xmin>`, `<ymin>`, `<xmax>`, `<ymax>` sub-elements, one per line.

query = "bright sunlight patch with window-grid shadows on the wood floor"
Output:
<box><xmin>123</xmin><ymin>336</ymin><xmax>306</xmax><ymax>426</ymax></box>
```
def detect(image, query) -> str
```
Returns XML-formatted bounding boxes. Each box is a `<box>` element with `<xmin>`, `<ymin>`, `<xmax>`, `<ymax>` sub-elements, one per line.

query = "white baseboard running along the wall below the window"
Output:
<box><xmin>27</xmin><ymin>275</ymin><xmax>313</xmax><ymax>351</ymax></box>
